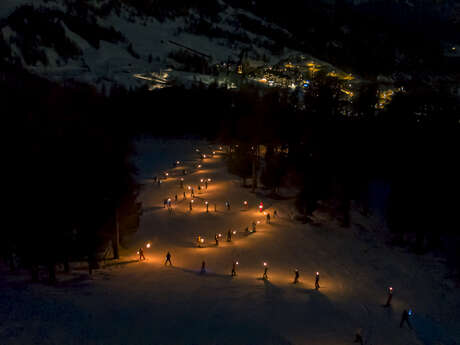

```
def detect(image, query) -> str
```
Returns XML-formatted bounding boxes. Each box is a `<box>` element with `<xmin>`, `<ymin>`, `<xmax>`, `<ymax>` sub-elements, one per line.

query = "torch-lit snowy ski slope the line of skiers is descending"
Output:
<box><xmin>0</xmin><ymin>140</ymin><xmax>460</xmax><ymax>345</ymax></box>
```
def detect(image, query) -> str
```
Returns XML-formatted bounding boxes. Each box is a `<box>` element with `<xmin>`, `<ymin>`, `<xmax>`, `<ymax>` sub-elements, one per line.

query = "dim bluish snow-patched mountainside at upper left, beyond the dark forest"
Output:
<box><xmin>0</xmin><ymin>0</ymin><xmax>300</xmax><ymax>86</ymax></box>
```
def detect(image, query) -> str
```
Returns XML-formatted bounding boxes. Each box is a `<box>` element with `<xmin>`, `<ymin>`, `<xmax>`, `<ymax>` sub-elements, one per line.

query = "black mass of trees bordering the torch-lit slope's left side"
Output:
<box><xmin>0</xmin><ymin>67</ymin><xmax>136</xmax><ymax>282</ymax></box>
